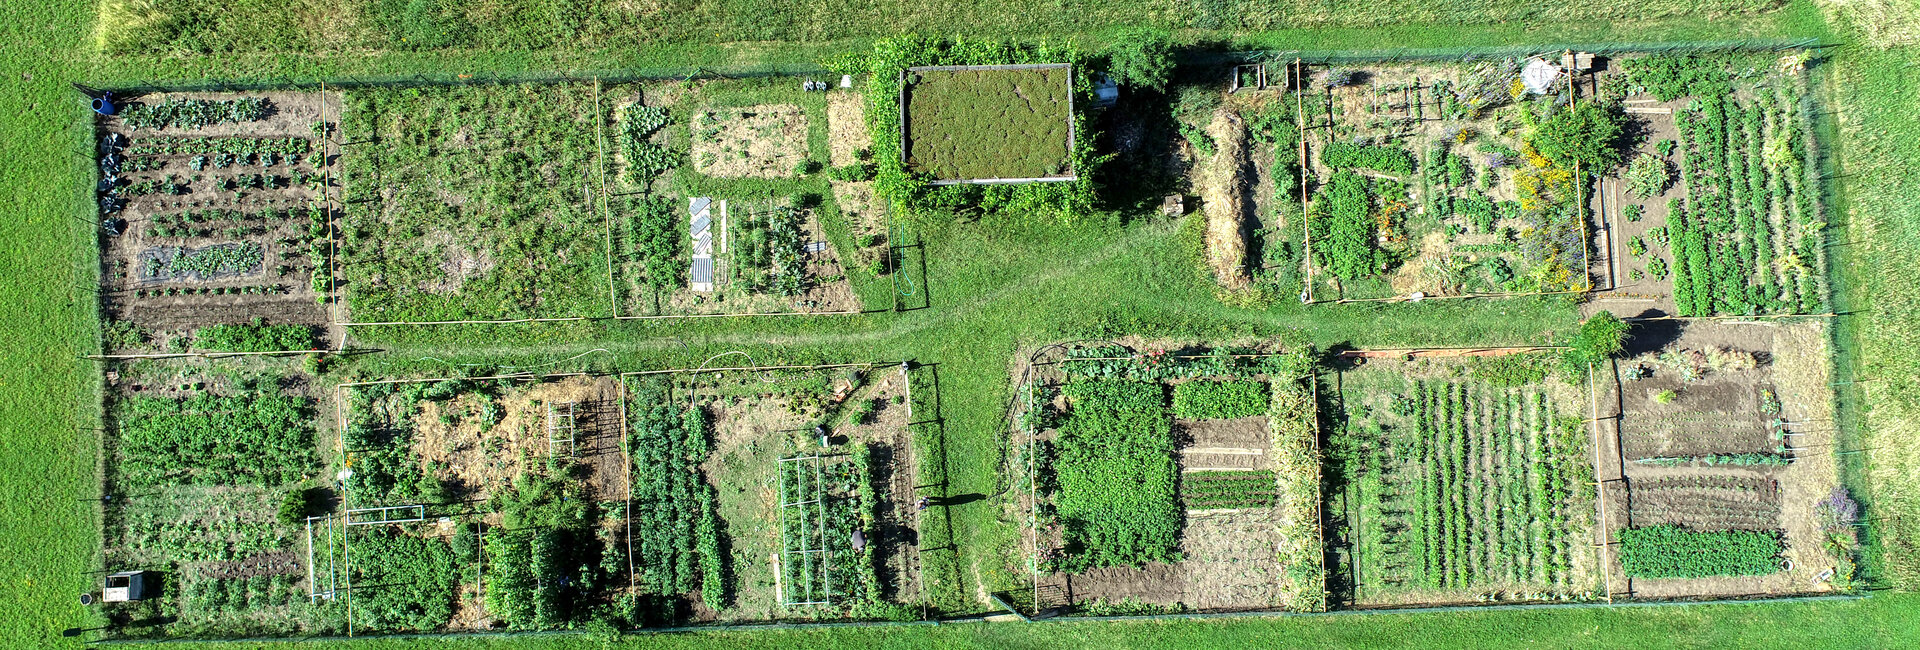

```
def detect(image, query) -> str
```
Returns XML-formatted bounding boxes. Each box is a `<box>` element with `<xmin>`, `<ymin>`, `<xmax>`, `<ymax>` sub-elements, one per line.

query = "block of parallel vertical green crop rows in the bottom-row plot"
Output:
<box><xmin>1331</xmin><ymin>380</ymin><xmax>1592</xmax><ymax>598</ymax></box>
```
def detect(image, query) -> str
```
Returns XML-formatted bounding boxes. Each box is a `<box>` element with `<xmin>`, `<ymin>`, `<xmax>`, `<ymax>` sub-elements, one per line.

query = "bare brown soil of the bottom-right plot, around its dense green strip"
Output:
<box><xmin>1597</xmin><ymin>318</ymin><xmax>1839</xmax><ymax>598</ymax></box>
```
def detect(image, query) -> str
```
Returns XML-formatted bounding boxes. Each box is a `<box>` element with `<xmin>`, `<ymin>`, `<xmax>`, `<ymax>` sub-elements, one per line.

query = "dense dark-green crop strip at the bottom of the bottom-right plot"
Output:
<box><xmin>1619</xmin><ymin>525</ymin><xmax>1782</xmax><ymax>577</ymax></box>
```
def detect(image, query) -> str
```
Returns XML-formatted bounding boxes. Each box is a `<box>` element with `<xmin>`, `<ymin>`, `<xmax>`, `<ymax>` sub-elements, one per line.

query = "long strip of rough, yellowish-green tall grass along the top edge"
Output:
<box><xmin>94</xmin><ymin>0</ymin><xmax>1786</xmax><ymax>54</ymax></box>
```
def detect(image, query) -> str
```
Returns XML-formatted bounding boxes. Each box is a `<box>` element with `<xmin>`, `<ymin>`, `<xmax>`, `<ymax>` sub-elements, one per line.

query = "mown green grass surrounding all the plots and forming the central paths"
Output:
<box><xmin>0</xmin><ymin>0</ymin><xmax>1920</xmax><ymax>648</ymax></box>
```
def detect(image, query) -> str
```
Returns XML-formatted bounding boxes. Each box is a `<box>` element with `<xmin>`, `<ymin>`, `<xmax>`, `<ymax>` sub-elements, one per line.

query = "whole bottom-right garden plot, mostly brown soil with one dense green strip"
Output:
<box><xmin>1599</xmin><ymin>320</ymin><xmax>1859</xmax><ymax>598</ymax></box>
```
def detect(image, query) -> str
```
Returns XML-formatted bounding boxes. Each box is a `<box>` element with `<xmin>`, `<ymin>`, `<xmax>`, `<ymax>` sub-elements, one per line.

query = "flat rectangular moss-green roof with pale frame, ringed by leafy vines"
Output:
<box><xmin>904</xmin><ymin>65</ymin><xmax>1073</xmax><ymax>180</ymax></box>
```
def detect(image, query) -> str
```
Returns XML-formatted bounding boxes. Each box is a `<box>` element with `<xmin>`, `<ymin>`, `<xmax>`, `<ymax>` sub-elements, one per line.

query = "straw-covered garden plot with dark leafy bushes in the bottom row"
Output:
<box><xmin>330</xmin><ymin>376</ymin><xmax>632</xmax><ymax>631</ymax></box>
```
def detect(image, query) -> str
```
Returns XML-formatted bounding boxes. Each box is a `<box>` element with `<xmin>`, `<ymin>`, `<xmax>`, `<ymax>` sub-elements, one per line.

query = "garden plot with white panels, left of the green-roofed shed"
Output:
<box><xmin>603</xmin><ymin>79</ymin><xmax>860</xmax><ymax>318</ymax></box>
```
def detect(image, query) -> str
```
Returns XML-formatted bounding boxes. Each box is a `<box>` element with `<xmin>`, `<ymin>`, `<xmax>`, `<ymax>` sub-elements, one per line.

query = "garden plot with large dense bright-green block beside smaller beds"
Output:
<box><xmin>1016</xmin><ymin>347</ymin><xmax>1325</xmax><ymax>614</ymax></box>
